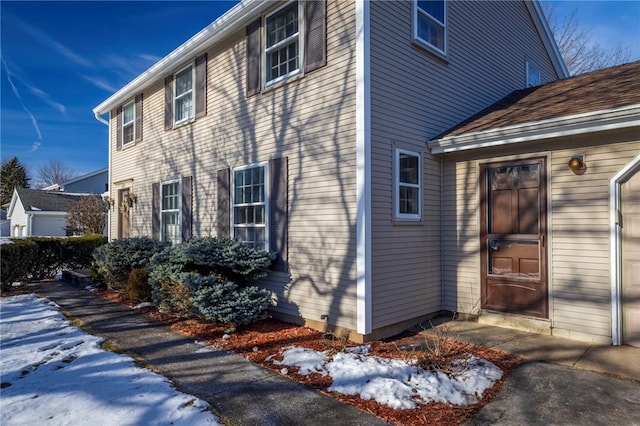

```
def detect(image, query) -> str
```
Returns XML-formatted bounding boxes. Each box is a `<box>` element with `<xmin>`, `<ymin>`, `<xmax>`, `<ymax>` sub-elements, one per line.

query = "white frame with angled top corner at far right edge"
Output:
<box><xmin>609</xmin><ymin>155</ymin><xmax>640</xmax><ymax>346</ymax></box>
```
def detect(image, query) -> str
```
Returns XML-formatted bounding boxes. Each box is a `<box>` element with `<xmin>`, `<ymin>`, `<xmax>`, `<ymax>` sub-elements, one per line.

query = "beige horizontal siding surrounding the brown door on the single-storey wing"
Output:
<box><xmin>443</xmin><ymin>130</ymin><xmax>640</xmax><ymax>342</ymax></box>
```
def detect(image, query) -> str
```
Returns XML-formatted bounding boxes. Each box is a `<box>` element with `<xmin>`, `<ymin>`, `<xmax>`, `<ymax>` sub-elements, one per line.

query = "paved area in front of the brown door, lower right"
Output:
<box><xmin>419</xmin><ymin>321</ymin><xmax>640</xmax><ymax>426</ymax></box>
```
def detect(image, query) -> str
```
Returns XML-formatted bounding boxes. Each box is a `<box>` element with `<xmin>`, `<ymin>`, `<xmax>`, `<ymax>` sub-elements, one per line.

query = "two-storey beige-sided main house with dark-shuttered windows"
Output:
<box><xmin>93</xmin><ymin>0</ymin><xmax>592</xmax><ymax>341</ymax></box>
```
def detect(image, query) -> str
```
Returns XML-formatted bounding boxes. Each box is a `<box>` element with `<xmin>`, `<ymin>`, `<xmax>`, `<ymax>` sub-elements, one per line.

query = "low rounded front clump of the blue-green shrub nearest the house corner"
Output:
<box><xmin>191</xmin><ymin>276</ymin><xmax>271</xmax><ymax>325</ymax></box>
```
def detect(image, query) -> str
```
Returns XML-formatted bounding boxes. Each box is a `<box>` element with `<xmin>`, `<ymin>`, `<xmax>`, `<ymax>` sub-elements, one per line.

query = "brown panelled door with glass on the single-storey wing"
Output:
<box><xmin>480</xmin><ymin>158</ymin><xmax>548</xmax><ymax>318</ymax></box>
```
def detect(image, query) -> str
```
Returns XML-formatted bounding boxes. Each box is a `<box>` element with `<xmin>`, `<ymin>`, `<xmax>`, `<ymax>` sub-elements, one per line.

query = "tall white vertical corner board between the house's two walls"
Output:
<box><xmin>356</xmin><ymin>0</ymin><xmax>372</xmax><ymax>335</ymax></box>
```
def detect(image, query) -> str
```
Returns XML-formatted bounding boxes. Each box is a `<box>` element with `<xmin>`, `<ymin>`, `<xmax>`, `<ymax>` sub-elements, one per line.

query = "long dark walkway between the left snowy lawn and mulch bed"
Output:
<box><xmin>32</xmin><ymin>281</ymin><xmax>386</xmax><ymax>426</ymax></box>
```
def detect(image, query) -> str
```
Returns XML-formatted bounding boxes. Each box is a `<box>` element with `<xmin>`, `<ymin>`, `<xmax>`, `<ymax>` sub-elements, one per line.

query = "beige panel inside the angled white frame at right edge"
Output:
<box><xmin>621</xmin><ymin>172</ymin><xmax>640</xmax><ymax>347</ymax></box>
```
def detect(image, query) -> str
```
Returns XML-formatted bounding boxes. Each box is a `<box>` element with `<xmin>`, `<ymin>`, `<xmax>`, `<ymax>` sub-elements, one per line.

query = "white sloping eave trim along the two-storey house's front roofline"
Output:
<box><xmin>93</xmin><ymin>0</ymin><xmax>274</xmax><ymax>117</ymax></box>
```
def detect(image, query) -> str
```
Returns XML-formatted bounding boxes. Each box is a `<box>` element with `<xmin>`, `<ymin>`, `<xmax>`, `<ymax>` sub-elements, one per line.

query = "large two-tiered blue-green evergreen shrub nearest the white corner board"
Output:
<box><xmin>149</xmin><ymin>237</ymin><xmax>275</xmax><ymax>325</ymax></box>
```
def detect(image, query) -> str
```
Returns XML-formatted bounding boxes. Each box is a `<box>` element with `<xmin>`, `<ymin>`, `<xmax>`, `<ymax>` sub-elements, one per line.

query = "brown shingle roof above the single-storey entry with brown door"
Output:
<box><xmin>435</xmin><ymin>61</ymin><xmax>640</xmax><ymax>139</ymax></box>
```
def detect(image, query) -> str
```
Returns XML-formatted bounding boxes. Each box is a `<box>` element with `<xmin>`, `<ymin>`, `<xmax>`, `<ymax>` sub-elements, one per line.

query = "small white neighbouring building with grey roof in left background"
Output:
<box><xmin>7</xmin><ymin>188</ymin><xmax>99</xmax><ymax>237</ymax></box>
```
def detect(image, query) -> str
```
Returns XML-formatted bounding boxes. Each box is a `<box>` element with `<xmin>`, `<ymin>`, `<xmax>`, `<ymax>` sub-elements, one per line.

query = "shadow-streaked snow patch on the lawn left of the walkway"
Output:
<box><xmin>0</xmin><ymin>294</ymin><xmax>221</xmax><ymax>425</ymax></box>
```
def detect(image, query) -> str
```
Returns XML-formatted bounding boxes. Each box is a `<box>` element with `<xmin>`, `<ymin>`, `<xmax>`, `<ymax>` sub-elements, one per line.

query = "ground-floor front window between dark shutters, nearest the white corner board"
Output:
<box><xmin>233</xmin><ymin>163</ymin><xmax>269</xmax><ymax>250</ymax></box>
